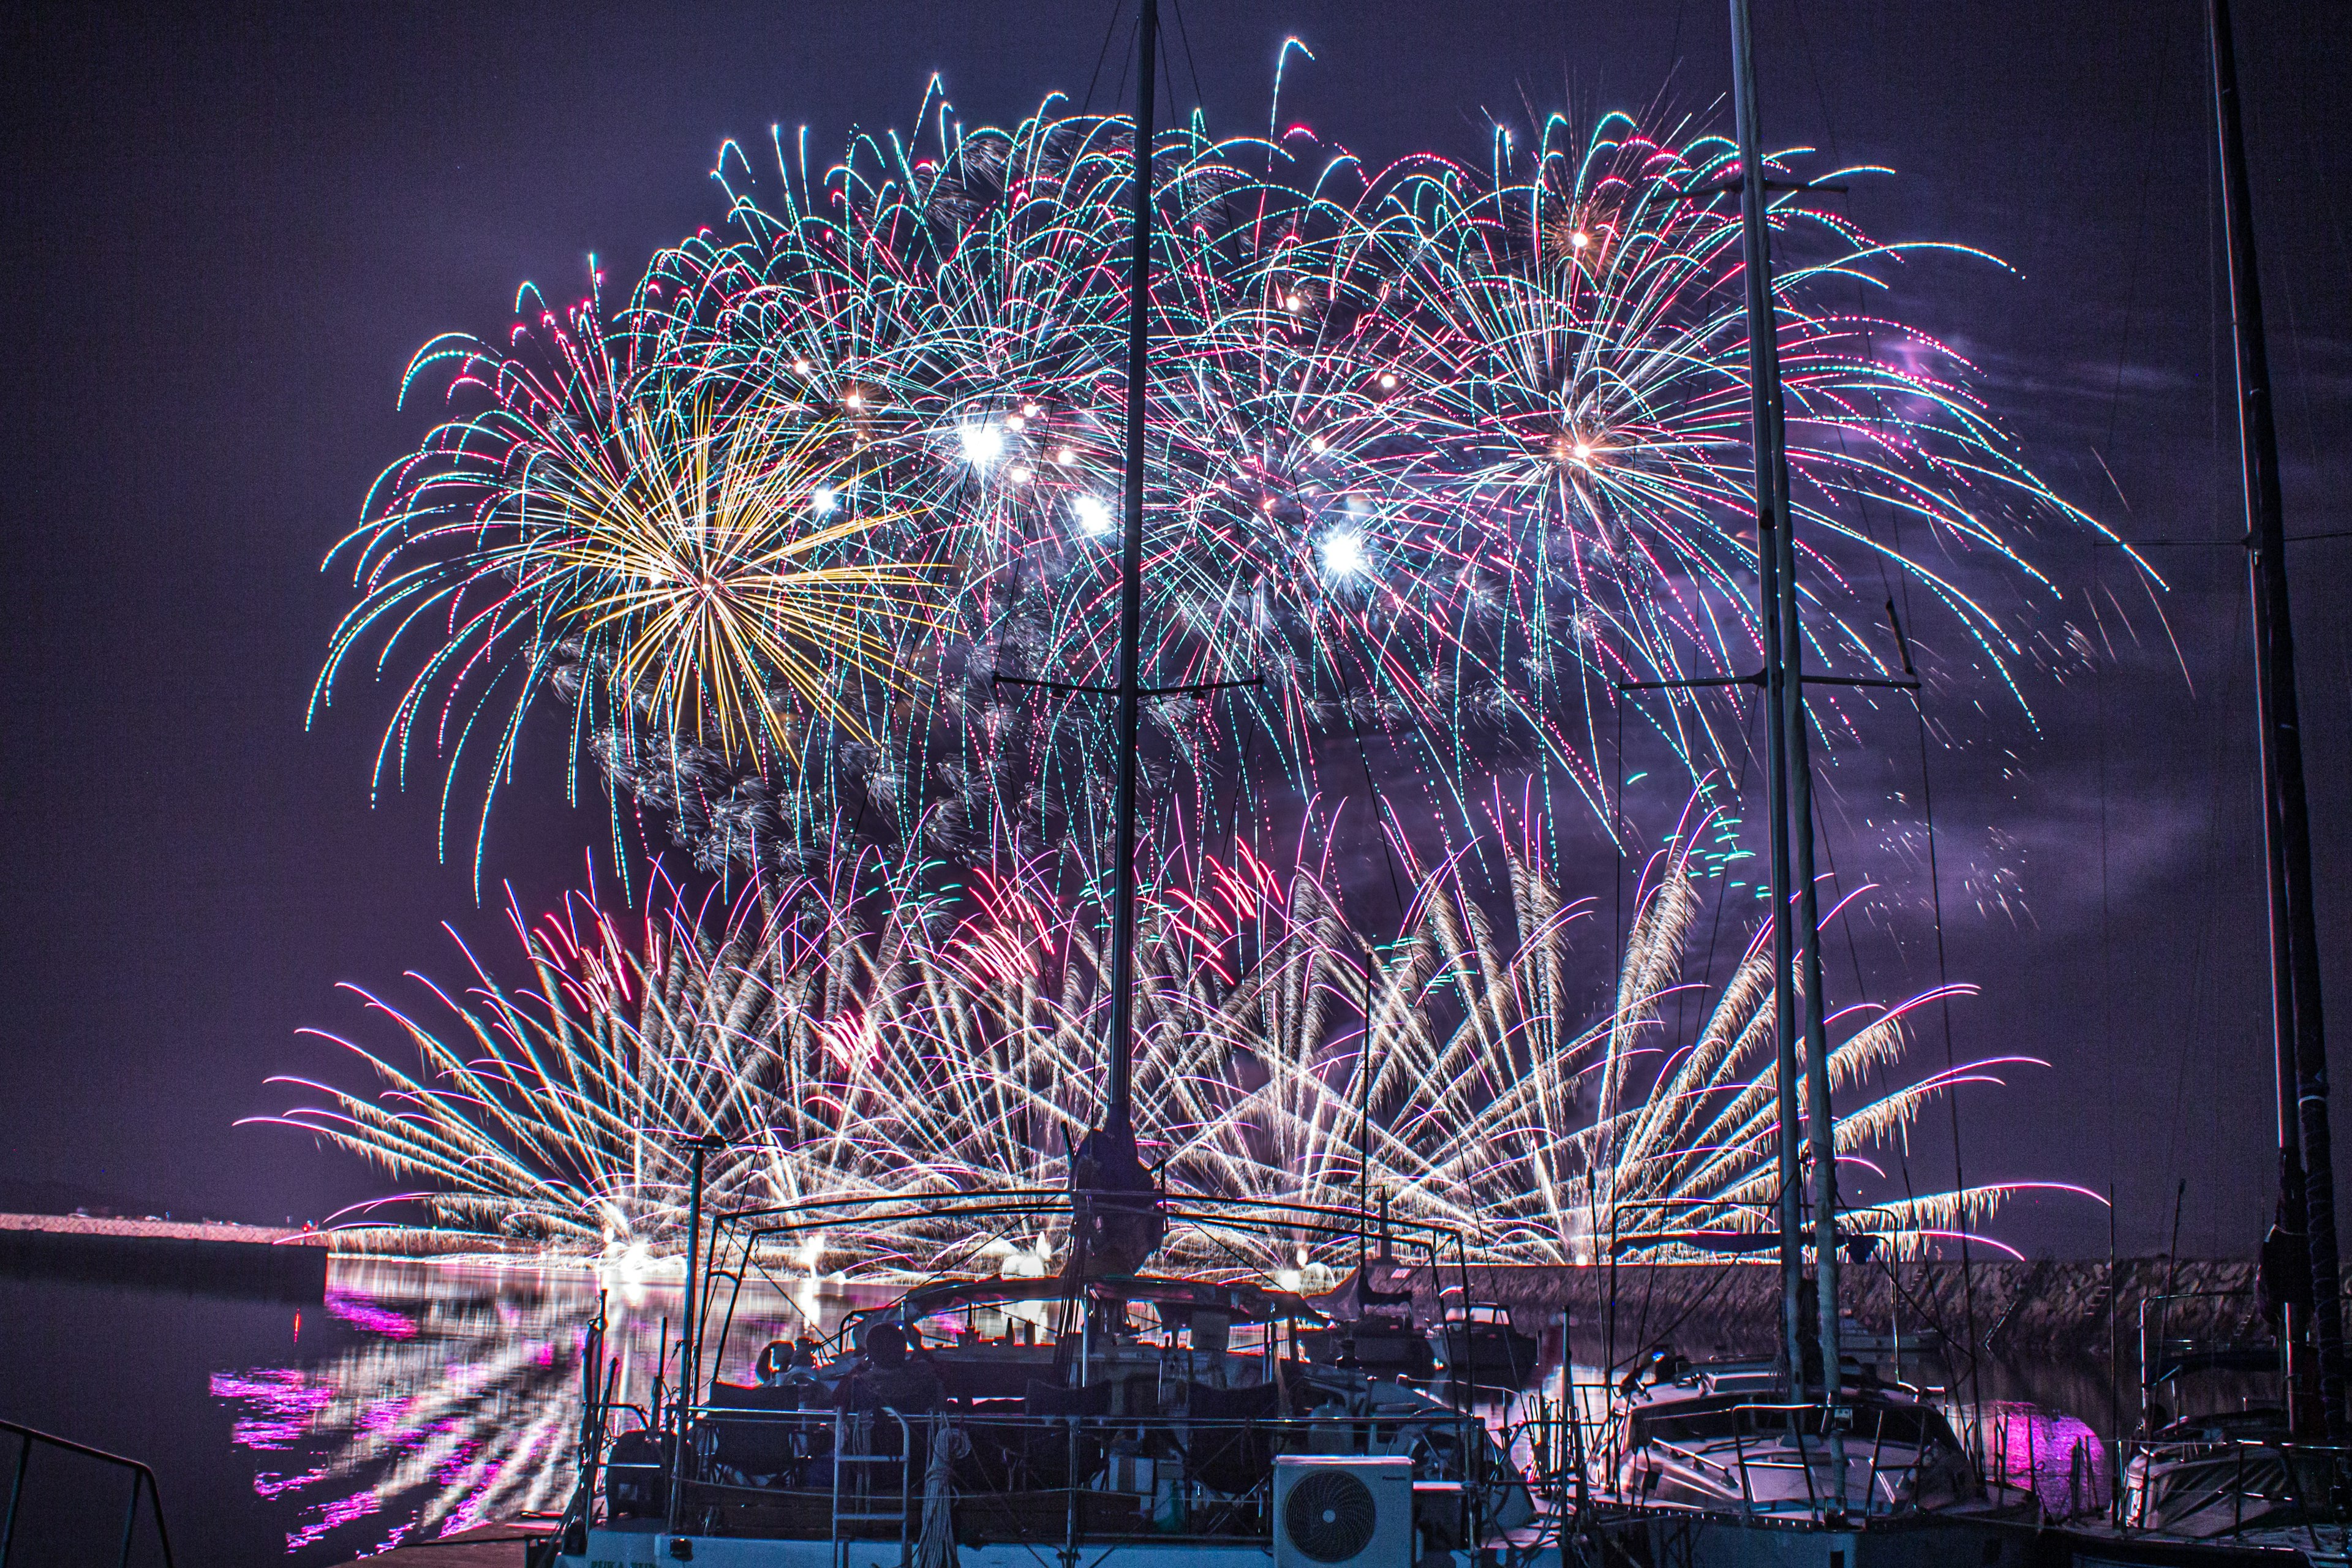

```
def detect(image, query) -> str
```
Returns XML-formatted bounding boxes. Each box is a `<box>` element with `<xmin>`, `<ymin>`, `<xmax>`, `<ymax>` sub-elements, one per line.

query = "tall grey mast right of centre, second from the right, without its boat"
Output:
<box><xmin>1731</xmin><ymin>0</ymin><xmax>1846</xmax><ymax>1512</ymax></box>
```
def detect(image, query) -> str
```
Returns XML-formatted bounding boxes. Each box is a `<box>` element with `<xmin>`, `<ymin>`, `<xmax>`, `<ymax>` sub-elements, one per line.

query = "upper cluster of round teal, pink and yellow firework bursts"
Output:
<box><xmin>320</xmin><ymin>87</ymin><xmax>2135</xmax><ymax>875</ymax></box>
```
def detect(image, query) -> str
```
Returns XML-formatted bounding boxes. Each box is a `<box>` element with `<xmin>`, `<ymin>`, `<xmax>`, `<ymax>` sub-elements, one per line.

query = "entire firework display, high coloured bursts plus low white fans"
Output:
<box><xmin>277</xmin><ymin>76</ymin><xmax>2095</xmax><ymax>1276</ymax></box>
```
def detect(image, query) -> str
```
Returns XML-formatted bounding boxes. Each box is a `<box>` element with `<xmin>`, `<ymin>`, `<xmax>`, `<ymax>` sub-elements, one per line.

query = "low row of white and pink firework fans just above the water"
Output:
<box><xmin>248</xmin><ymin>809</ymin><xmax>2070</xmax><ymax>1276</ymax></box>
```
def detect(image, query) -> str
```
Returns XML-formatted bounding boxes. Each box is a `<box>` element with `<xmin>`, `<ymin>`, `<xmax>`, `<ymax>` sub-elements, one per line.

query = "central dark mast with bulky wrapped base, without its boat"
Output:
<box><xmin>1070</xmin><ymin>0</ymin><xmax>1159</xmax><ymax>1274</ymax></box>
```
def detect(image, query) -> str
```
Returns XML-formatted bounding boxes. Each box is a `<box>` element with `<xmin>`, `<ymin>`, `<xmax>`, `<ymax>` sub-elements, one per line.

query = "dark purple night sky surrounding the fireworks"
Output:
<box><xmin>0</xmin><ymin>0</ymin><xmax>2352</xmax><ymax>1253</ymax></box>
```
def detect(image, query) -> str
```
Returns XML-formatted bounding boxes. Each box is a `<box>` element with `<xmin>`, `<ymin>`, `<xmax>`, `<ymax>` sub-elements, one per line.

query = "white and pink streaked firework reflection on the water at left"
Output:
<box><xmin>212</xmin><ymin>1260</ymin><xmax>870</xmax><ymax>1556</ymax></box>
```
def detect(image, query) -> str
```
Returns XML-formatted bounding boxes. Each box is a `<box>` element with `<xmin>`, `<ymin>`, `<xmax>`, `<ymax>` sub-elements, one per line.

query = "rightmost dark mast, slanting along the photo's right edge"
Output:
<box><xmin>2206</xmin><ymin>0</ymin><xmax>2345</xmax><ymax>1441</ymax></box>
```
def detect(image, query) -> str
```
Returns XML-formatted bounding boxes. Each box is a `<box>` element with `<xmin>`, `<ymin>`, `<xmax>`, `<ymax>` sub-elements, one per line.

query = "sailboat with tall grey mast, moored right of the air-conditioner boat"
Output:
<box><xmin>1597</xmin><ymin>0</ymin><xmax>2051</xmax><ymax>1563</ymax></box>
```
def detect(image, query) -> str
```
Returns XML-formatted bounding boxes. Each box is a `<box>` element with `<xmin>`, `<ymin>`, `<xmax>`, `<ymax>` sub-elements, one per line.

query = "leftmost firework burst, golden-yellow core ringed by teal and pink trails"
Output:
<box><xmin>315</xmin><ymin>312</ymin><xmax>933</xmax><ymax>870</ymax></box>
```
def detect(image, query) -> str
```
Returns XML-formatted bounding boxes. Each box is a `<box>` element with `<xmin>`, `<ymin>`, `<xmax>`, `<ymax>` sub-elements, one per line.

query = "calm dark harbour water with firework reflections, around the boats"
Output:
<box><xmin>0</xmin><ymin>1262</ymin><xmax>2136</xmax><ymax>1568</ymax></box>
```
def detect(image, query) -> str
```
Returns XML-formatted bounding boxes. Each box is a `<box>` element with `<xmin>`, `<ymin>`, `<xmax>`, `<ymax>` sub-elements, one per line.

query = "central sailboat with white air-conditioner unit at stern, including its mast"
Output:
<box><xmin>541</xmin><ymin>0</ymin><xmax>1536</xmax><ymax>1568</ymax></box>
